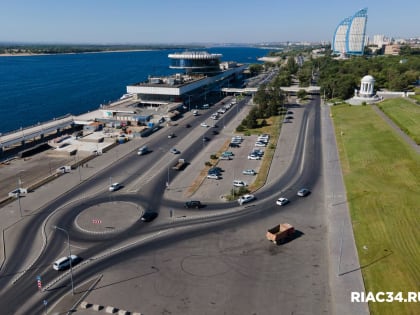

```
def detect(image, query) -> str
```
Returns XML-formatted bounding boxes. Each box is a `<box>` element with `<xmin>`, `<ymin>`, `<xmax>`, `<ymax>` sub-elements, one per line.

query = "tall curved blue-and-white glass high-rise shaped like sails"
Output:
<box><xmin>332</xmin><ymin>8</ymin><xmax>367</xmax><ymax>55</ymax></box>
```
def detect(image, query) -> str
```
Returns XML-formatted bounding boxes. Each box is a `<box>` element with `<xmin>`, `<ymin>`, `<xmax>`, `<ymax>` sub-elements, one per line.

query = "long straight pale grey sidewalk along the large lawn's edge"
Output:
<box><xmin>321</xmin><ymin>105</ymin><xmax>369</xmax><ymax>315</ymax></box>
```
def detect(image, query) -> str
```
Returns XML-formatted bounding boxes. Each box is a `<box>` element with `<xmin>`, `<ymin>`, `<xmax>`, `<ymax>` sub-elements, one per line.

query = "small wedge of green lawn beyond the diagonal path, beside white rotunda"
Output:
<box><xmin>378</xmin><ymin>98</ymin><xmax>420</xmax><ymax>144</ymax></box>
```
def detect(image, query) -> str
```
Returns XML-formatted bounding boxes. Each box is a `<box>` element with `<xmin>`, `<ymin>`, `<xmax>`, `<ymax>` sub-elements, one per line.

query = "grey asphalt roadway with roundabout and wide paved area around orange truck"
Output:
<box><xmin>0</xmin><ymin>95</ymin><xmax>368</xmax><ymax>314</ymax></box>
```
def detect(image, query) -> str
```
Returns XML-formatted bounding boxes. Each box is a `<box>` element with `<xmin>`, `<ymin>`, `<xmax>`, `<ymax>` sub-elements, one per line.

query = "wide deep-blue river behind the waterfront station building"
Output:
<box><xmin>0</xmin><ymin>47</ymin><xmax>269</xmax><ymax>133</ymax></box>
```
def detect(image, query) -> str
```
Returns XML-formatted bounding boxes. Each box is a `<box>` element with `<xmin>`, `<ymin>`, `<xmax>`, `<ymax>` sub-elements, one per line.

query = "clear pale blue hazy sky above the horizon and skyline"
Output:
<box><xmin>0</xmin><ymin>0</ymin><xmax>420</xmax><ymax>44</ymax></box>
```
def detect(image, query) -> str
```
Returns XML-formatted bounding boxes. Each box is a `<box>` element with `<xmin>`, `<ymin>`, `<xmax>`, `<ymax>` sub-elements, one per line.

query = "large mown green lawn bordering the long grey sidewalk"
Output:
<box><xmin>332</xmin><ymin>105</ymin><xmax>420</xmax><ymax>315</ymax></box>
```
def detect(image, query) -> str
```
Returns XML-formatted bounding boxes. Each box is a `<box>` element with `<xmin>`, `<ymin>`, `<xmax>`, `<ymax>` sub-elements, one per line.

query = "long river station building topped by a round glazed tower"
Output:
<box><xmin>127</xmin><ymin>51</ymin><xmax>247</xmax><ymax>112</ymax></box>
